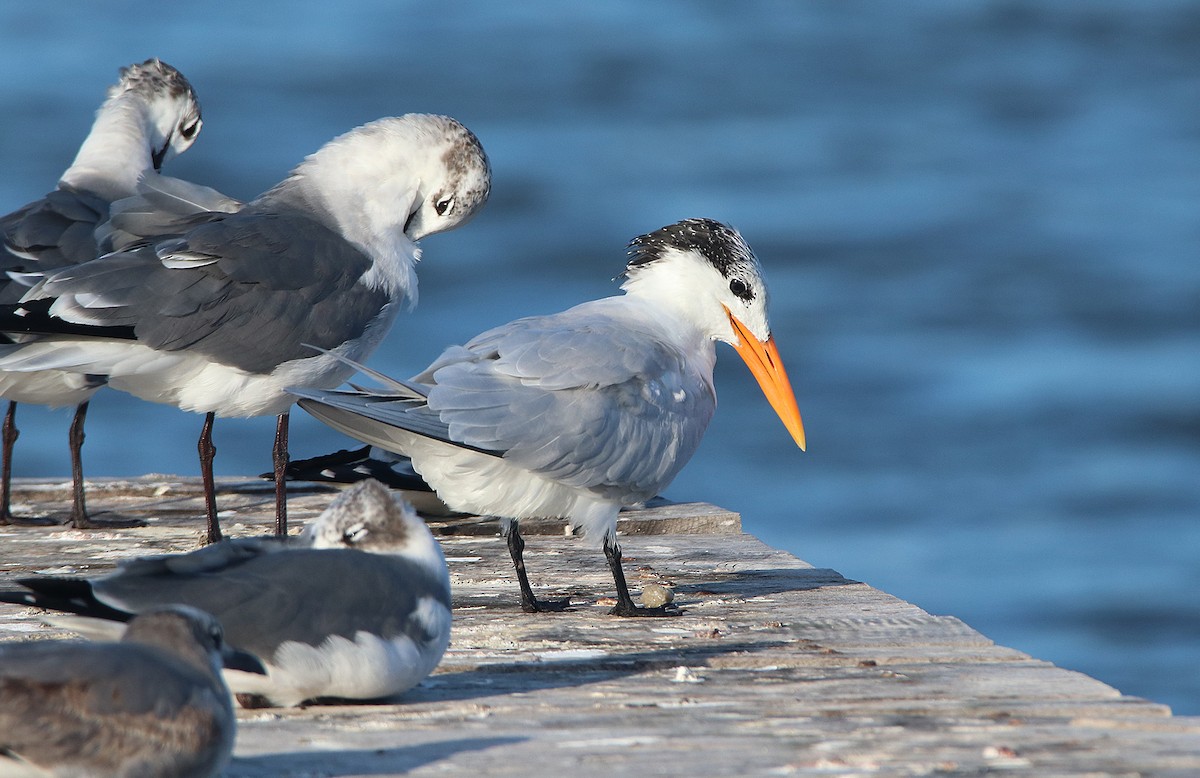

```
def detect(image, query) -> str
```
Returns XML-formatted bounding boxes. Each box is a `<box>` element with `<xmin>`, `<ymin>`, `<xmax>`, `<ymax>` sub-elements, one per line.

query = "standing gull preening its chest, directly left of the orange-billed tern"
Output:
<box><xmin>0</xmin><ymin>114</ymin><xmax>491</xmax><ymax>541</ymax></box>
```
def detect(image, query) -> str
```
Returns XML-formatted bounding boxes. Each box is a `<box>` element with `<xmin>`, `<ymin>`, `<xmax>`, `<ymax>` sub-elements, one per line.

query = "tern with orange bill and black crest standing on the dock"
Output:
<box><xmin>292</xmin><ymin>219</ymin><xmax>804</xmax><ymax>616</ymax></box>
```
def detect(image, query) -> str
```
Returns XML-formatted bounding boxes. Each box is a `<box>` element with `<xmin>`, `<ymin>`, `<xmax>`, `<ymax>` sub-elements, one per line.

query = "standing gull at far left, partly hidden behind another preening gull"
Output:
<box><xmin>0</xmin><ymin>59</ymin><xmax>202</xmax><ymax>528</ymax></box>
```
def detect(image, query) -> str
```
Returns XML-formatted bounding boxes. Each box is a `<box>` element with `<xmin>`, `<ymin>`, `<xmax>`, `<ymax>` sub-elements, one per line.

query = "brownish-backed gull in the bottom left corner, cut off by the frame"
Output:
<box><xmin>0</xmin><ymin>606</ymin><xmax>236</xmax><ymax>778</ymax></box>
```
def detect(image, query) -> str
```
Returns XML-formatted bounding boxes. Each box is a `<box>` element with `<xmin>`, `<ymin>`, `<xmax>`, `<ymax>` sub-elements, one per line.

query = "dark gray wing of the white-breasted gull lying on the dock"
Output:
<box><xmin>92</xmin><ymin>549</ymin><xmax>450</xmax><ymax>659</ymax></box>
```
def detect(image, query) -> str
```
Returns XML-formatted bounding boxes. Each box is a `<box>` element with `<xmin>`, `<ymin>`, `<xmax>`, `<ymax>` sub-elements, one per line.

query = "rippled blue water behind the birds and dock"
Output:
<box><xmin>0</xmin><ymin>0</ymin><xmax>1200</xmax><ymax>713</ymax></box>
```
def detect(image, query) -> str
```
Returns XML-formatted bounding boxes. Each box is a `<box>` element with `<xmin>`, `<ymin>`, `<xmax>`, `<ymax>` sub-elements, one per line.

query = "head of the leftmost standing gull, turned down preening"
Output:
<box><xmin>108</xmin><ymin>59</ymin><xmax>203</xmax><ymax>170</ymax></box>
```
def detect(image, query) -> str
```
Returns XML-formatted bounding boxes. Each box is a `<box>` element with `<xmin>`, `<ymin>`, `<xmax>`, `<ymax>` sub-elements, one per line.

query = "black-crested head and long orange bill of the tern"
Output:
<box><xmin>622</xmin><ymin>219</ymin><xmax>804</xmax><ymax>449</ymax></box>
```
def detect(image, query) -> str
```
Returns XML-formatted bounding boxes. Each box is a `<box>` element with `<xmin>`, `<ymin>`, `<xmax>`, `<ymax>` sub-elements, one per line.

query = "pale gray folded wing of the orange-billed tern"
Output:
<box><xmin>298</xmin><ymin>305</ymin><xmax>716</xmax><ymax>496</ymax></box>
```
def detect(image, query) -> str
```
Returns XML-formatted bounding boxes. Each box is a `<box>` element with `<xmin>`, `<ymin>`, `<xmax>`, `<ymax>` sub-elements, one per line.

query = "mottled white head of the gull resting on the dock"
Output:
<box><xmin>300</xmin><ymin>478</ymin><xmax>446</xmax><ymax>575</ymax></box>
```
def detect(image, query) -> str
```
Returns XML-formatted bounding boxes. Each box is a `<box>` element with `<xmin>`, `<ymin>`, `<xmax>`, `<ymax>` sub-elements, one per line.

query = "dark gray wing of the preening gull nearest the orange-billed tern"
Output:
<box><xmin>29</xmin><ymin>209</ymin><xmax>389</xmax><ymax>372</ymax></box>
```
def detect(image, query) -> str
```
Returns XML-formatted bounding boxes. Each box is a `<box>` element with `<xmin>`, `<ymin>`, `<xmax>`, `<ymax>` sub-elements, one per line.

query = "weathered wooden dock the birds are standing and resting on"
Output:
<box><xmin>0</xmin><ymin>477</ymin><xmax>1200</xmax><ymax>778</ymax></box>
